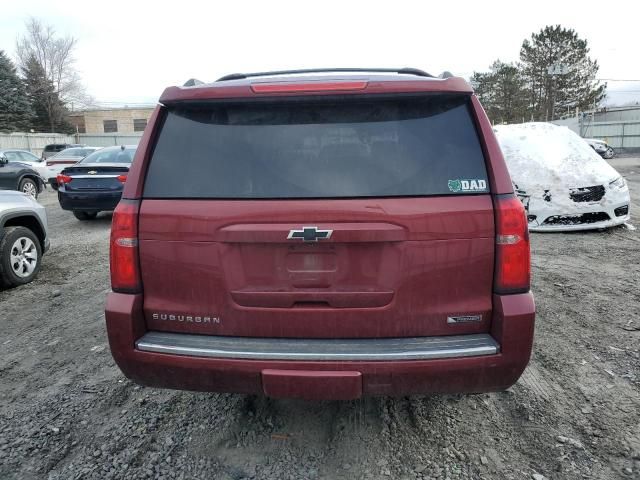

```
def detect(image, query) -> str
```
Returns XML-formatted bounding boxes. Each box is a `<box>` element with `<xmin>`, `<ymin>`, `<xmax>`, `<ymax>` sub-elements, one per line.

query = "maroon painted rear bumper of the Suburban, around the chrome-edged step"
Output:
<box><xmin>105</xmin><ymin>293</ymin><xmax>535</xmax><ymax>400</ymax></box>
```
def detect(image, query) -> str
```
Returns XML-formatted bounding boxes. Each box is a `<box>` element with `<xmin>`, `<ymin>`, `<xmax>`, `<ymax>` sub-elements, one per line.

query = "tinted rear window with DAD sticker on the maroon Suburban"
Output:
<box><xmin>144</xmin><ymin>94</ymin><xmax>488</xmax><ymax>199</ymax></box>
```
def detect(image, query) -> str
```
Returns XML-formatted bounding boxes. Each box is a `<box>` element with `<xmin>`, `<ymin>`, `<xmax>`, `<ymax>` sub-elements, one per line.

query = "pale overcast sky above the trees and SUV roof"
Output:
<box><xmin>0</xmin><ymin>0</ymin><xmax>640</xmax><ymax>106</ymax></box>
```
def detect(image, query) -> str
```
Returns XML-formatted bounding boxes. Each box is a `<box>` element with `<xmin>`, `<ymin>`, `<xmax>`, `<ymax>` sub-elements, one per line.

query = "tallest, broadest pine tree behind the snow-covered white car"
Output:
<box><xmin>520</xmin><ymin>25</ymin><xmax>606</xmax><ymax>120</ymax></box>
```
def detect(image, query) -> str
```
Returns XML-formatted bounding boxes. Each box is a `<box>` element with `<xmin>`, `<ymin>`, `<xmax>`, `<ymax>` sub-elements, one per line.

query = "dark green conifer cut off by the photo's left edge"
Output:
<box><xmin>0</xmin><ymin>50</ymin><xmax>33</xmax><ymax>132</ymax></box>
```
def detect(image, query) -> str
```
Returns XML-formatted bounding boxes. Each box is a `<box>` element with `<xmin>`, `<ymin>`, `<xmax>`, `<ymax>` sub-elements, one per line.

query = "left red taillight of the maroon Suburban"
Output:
<box><xmin>109</xmin><ymin>200</ymin><xmax>142</xmax><ymax>293</ymax></box>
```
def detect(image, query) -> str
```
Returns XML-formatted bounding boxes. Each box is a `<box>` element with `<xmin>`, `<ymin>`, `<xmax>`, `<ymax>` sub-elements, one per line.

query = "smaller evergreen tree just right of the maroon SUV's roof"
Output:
<box><xmin>471</xmin><ymin>60</ymin><xmax>530</xmax><ymax>123</ymax></box>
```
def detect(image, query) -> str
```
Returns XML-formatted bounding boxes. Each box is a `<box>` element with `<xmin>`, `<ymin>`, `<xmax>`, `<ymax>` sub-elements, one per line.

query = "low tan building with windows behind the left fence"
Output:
<box><xmin>69</xmin><ymin>107</ymin><xmax>153</xmax><ymax>134</ymax></box>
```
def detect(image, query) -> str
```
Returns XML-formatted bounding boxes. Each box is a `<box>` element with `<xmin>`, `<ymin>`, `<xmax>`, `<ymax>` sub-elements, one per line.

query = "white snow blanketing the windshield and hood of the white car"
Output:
<box><xmin>494</xmin><ymin>123</ymin><xmax>620</xmax><ymax>200</ymax></box>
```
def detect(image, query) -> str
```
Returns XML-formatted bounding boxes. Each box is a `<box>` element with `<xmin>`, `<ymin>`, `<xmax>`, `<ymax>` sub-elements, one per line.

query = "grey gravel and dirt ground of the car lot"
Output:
<box><xmin>0</xmin><ymin>158</ymin><xmax>640</xmax><ymax>480</ymax></box>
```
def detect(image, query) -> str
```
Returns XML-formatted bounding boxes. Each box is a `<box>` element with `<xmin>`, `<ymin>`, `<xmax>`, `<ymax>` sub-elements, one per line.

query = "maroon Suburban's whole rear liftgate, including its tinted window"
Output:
<box><xmin>139</xmin><ymin>95</ymin><xmax>494</xmax><ymax>338</ymax></box>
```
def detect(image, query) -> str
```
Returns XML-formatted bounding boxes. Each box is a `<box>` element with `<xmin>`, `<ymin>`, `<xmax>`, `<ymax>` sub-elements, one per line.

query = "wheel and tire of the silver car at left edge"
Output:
<box><xmin>0</xmin><ymin>227</ymin><xmax>42</xmax><ymax>287</ymax></box>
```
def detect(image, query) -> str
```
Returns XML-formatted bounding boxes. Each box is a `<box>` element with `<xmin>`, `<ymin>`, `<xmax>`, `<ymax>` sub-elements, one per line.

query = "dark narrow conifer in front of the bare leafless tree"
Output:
<box><xmin>22</xmin><ymin>58</ymin><xmax>73</xmax><ymax>133</ymax></box>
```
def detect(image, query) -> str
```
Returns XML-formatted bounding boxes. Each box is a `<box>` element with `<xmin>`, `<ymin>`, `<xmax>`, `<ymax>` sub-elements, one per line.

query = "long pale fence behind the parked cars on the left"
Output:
<box><xmin>0</xmin><ymin>133</ymin><xmax>142</xmax><ymax>156</ymax></box>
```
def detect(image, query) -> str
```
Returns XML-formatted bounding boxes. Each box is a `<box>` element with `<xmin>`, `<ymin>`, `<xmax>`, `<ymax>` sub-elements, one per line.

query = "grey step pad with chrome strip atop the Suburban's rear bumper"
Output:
<box><xmin>136</xmin><ymin>332</ymin><xmax>500</xmax><ymax>361</ymax></box>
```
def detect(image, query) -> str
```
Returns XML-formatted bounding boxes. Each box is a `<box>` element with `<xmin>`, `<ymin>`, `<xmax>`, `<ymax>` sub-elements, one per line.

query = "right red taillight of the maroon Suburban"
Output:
<box><xmin>494</xmin><ymin>194</ymin><xmax>531</xmax><ymax>294</ymax></box>
